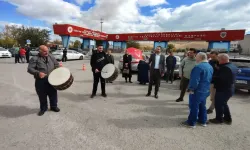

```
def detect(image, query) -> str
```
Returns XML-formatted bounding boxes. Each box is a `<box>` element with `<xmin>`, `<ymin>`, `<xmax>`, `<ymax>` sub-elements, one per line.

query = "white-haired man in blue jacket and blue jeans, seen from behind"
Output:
<box><xmin>182</xmin><ymin>52</ymin><xmax>213</xmax><ymax>128</ymax></box>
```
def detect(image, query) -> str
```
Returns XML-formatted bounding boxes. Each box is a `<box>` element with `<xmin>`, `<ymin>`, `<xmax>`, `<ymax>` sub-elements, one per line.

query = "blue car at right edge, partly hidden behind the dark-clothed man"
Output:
<box><xmin>230</xmin><ymin>58</ymin><xmax>250</xmax><ymax>93</ymax></box>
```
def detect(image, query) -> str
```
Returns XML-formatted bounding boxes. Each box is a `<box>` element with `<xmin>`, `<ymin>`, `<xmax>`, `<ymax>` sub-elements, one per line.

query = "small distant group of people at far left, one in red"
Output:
<box><xmin>14</xmin><ymin>46</ymin><xmax>30</xmax><ymax>64</ymax></box>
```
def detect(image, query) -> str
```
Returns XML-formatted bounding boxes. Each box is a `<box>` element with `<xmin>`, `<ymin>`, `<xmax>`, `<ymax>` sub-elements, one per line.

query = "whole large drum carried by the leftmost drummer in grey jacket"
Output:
<box><xmin>48</xmin><ymin>67</ymin><xmax>74</xmax><ymax>90</ymax></box>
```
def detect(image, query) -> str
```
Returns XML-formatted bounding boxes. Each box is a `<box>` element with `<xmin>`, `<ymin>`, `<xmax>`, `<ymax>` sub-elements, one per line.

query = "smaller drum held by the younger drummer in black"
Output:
<box><xmin>101</xmin><ymin>64</ymin><xmax>119</xmax><ymax>82</ymax></box>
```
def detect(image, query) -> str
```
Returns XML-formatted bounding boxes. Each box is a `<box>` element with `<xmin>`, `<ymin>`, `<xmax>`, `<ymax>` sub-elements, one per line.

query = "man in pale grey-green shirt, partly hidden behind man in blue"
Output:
<box><xmin>176</xmin><ymin>48</ymin><xmax>196</xmax><ymax>102</ymax></box>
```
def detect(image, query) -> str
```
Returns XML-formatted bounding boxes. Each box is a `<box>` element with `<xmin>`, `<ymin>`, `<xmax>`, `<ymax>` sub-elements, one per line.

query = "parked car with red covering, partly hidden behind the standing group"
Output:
<box><xmin>118</xmin><ymin>47</ymin><xmax>144</xmax><ymax>71</ymax></box>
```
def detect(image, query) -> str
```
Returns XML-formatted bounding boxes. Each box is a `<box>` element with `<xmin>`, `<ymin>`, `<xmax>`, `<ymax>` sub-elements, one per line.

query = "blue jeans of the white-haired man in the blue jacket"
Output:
<box><xmin>187</xmin><ymin>93</ymin><xmax>209</xmax><ymax>126</ymax></box>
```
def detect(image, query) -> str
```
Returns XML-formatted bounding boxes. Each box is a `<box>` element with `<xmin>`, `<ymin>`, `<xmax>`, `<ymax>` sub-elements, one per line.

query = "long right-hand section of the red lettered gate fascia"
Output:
<box><xmin>108</xmin><ymin>30</ymin><xmax>245</xmax><ymax>41</ymax></box>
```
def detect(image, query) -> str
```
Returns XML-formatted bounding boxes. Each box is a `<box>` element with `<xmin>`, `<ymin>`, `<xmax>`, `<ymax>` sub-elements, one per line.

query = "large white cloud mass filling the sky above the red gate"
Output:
<box><xmin>1</xmin><ymin>0</ymin><xmax>250</xmax><ymax>33</ymax></box>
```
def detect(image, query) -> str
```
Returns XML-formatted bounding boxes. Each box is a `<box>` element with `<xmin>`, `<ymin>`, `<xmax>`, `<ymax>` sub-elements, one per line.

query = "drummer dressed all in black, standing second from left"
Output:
<box><xmin>90</xmin><ymin>45</ymin><xmax>108</xmax><ymax>98</ymax></box>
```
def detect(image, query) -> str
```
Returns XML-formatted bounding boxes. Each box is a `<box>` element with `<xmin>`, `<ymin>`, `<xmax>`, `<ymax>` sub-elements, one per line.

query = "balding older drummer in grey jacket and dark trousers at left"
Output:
<box><xmin>28</xmin><ymin>45</ymin><xmax>60</xmax><ymax>116</ymax></box>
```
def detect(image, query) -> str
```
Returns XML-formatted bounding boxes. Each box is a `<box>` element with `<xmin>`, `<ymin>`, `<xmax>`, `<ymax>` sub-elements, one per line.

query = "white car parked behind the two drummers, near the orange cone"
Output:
<box><xmin>52</xmin><ymin>50</ymin><xmax>85</xmax><ymax>60</ymax></box>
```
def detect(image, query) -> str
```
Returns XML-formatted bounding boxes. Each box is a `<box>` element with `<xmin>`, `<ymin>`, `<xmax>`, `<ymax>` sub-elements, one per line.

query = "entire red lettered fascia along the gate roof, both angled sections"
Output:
<box><xmin>53</xmin><ymin>24</ymin><xmax>245</xmax><ymax>41</ymax></box>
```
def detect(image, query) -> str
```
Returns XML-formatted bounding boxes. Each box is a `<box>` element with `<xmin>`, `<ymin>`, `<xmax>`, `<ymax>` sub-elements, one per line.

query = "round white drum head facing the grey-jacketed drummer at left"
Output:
<box><xmin>48</xmin><ymin>67</ymin><xmax>71</xmax><ymax>86</ymax></box>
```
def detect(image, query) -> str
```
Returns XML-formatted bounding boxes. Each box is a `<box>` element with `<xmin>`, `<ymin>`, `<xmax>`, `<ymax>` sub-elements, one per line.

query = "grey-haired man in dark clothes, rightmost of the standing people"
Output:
<box><xmin>209</xmin><ymin>53</ymin><xmax>238</xmax><ymax>125</ymax></box>
